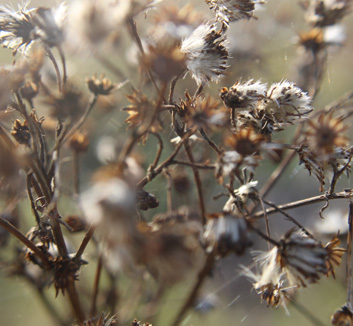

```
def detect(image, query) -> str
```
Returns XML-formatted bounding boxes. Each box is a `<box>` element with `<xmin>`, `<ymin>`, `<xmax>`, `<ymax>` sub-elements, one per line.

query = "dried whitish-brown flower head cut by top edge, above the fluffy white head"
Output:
<box><xmin>205</xmin><ymin>0</ymin><xmax>266</xmax><ymax>25</ymax></box>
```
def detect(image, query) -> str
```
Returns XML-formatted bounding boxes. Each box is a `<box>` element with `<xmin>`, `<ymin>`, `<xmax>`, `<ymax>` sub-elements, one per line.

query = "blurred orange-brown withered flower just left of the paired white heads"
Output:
<box><xmin>177</xmin><ymin>92</ymin><xmax>226</xmax><ymax>129</ymax></box>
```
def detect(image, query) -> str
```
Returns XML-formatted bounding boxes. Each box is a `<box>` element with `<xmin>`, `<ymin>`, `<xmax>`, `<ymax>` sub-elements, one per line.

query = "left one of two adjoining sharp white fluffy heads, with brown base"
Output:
<box><xmin>220</xmin><ymin>79</ymin><xmax>267</xmax><ymax>109</ymax></box>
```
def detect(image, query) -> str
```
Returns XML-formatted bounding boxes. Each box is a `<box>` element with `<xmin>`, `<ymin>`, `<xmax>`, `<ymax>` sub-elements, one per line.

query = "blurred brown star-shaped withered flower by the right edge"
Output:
<box><xmin>305</xmin><ymin>113</ymin><xmax>348</xmax><ymax>159</ymax></box>
